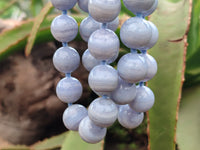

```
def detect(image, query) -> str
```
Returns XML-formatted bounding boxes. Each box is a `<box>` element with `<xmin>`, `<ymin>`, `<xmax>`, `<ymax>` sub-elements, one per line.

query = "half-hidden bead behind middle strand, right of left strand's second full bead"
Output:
<box><xmin>82</xmin><ymin>49</ymin><xmax>101</xmax><ymax>71</ymax></box>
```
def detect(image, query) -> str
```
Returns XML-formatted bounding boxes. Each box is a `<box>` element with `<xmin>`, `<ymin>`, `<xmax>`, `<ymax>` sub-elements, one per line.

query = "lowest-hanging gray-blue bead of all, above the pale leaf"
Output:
<box><xmin>79</xmin><ymin>117</ymin><xmax>107</xmax><ymax>144</ymax></box>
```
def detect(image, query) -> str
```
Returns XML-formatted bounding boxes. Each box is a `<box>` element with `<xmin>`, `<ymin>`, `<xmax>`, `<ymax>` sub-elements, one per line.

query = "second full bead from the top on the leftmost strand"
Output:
<box><xmin>53</xmin><ymin>47</ymin><xmax>80</xmax><ymax>74</ymax></box>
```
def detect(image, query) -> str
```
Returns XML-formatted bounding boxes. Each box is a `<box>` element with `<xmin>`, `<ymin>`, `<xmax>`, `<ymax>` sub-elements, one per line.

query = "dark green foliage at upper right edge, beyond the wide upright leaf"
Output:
<box><xmin>185</xmin><ymin>0</ymin><xmax>200</xmax><ymax>86</ymax></box>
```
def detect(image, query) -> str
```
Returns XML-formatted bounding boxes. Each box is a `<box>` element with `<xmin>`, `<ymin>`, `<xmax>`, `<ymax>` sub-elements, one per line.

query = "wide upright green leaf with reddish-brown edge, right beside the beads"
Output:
<box><xmin>148</xmin><ymin>0</ymin><xmax>190</xmax><ymax>150</ymax></box>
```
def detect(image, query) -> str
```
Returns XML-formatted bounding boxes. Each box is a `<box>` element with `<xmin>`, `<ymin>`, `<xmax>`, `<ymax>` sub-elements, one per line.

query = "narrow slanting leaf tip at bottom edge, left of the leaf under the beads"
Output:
<box><xmin>31</xmin><ymin>133</ymin><xmax>67</xmax><ymax>150</ymax></box>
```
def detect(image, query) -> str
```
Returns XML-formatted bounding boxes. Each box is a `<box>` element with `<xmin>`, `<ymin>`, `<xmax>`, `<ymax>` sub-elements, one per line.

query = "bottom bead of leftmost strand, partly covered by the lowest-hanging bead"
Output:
<box><xmin>63</xmin><ymin>104</ymin><xmax>88</xmax><ymax>131</ymax></box>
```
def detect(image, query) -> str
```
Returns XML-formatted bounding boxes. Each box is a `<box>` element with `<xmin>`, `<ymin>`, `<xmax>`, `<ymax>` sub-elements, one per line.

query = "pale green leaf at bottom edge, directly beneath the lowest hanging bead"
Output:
<box><xmin>61</xmin><ymin>131</ymin><xmax>103</xmax><ymax>150</ymax></box>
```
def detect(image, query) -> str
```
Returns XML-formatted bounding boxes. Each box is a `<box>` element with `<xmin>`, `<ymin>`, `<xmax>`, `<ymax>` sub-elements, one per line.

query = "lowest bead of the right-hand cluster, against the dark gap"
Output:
<box><xmin>118</xmin><ymin>105</ymin><xmax>144</xmax><ymax>129</ymax></box>
